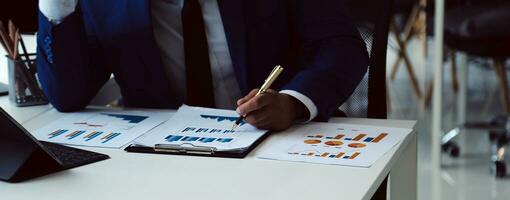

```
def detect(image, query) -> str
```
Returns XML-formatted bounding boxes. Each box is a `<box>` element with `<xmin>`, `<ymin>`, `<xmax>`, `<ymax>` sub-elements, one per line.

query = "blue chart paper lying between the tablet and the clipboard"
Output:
<box><xmin>33</xmin><ymin>110</ymin><xmax>171</xmax><ymax>148</ymax></box>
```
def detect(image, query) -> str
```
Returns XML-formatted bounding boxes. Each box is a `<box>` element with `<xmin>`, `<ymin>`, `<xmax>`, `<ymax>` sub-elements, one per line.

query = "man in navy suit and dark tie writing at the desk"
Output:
<box><xmin>37</xmin><ymin>0</ymin><xmax>368</xmax><ymax>130</ymax></box>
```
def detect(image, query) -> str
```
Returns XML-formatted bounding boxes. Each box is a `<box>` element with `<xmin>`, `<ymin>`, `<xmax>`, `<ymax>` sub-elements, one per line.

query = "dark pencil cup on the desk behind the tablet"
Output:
<box><xmin>7</xmin><ymin>54</ymin><xmax>48</xmax><ymax>107</ymax></box>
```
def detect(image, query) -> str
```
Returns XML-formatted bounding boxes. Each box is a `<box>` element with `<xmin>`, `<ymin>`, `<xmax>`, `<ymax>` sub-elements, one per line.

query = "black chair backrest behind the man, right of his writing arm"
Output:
<box><xmin>340</xmin><ymin>0</ymin><xmax>393</xmax><ymax>119</ymax></box>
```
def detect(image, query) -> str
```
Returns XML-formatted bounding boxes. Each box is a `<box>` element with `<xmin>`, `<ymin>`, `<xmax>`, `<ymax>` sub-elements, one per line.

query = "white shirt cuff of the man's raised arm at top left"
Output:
<box><xmin>39</xmin><ymin>0</ymin><xmax>78</xmax><ymax>24</ymax></box>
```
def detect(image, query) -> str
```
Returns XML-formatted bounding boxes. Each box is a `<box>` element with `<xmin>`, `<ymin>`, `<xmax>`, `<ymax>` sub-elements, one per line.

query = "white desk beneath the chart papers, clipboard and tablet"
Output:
<box><xmin>0</xmin><ymin>96</ymin><xmax>417</xmax><ymax>200</ymax></box>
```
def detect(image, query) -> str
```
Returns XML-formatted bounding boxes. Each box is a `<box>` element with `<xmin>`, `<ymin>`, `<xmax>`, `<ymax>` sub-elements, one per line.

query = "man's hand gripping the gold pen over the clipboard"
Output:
<box><xmin>236</xmin><ymin>89</ymin><xmax>309</xmax><ymax>131</ymax></box>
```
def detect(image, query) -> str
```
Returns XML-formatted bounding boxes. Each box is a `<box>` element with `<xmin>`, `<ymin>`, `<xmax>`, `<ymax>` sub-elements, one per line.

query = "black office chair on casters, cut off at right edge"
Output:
<box><xmin>442</xmin><ymin>0</ymin><xmax>510</xmax><ymax>177</ymax></box>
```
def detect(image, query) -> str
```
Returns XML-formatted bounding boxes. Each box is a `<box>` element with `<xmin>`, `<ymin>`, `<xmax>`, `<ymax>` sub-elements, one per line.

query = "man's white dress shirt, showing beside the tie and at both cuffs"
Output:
<box><xmin>39</xmin><ymin>0</ymin><xmax>317</xmax><ymax>121</ymax></box>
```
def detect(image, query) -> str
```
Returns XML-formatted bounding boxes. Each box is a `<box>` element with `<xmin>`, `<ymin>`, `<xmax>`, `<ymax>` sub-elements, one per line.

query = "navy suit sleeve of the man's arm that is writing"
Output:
<box><xmin>283</xmin><ymin>0</ymin><xmax>368</xmax><ymax>121</ymax></box>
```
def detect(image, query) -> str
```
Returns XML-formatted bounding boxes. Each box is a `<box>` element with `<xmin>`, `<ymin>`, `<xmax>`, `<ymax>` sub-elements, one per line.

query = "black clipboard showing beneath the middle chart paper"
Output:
<box><xmin>124</xmin><ymin>132</ymin><xmax>269</xmax><ymax>158</ymax></box>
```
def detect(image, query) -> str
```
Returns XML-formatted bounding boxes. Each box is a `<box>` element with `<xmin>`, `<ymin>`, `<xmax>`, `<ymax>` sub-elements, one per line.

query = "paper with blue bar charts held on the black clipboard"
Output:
<box><xmin>134</xmin><ymin>105</ymin><xmax>266</xmax><ymax>151</ymax></box>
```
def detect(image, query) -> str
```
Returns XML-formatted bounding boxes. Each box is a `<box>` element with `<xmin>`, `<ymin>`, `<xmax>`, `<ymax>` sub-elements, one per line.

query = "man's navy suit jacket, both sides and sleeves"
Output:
<box><xmin>37</xmin><ymin>0</ymin><xmax>368</xmax><ymax>120</ymax></box>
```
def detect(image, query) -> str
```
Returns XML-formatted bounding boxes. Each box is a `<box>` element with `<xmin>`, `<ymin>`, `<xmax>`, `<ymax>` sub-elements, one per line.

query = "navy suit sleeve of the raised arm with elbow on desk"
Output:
<box><xmin>37</xmin><ymin>8</ymin><xmax>111</xmax><ymax>112</ymax></box>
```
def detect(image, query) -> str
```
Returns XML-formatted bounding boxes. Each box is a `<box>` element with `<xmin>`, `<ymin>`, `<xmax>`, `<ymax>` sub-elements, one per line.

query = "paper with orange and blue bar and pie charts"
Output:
<box><xmin>257</xmin><ymin>123</ymin><xmax>412</xmax><ymax>167</ymax></box>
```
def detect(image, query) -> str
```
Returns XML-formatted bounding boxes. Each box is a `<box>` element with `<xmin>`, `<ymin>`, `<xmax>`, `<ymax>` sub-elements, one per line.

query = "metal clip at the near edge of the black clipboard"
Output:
<box><xmin>154</xmin><ymin>143</ymin><xmax>216</xmax><ymax>155</ymax></box>
